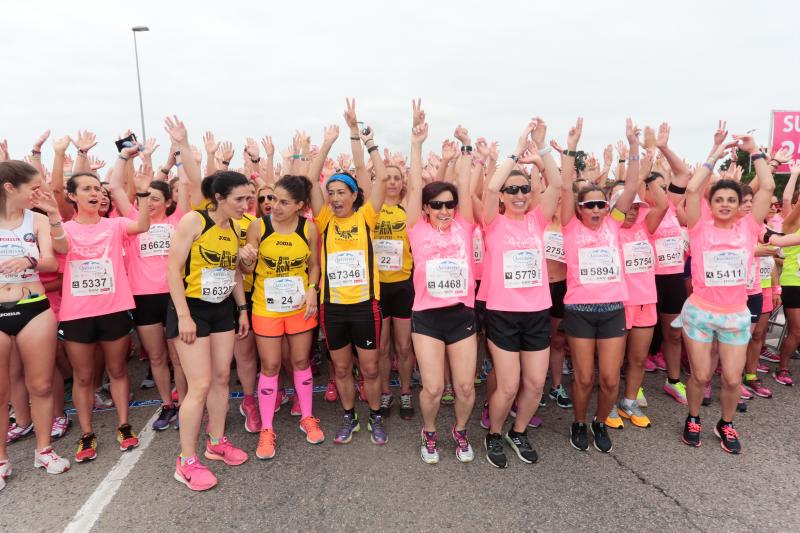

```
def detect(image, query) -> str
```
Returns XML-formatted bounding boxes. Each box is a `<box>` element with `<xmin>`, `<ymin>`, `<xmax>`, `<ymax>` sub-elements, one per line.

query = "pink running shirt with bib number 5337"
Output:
<box><xmin>59</xmin><ymin>217</ymin><xmax>134</xmax><ymax>321</ymax></box>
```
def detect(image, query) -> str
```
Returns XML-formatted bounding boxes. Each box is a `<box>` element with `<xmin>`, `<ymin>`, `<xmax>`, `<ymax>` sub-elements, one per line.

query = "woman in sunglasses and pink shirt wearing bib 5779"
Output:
<box><xmin>483</xmin><ymin>118</ymin><xmax>561</xmax><ymax>468</ymax></box>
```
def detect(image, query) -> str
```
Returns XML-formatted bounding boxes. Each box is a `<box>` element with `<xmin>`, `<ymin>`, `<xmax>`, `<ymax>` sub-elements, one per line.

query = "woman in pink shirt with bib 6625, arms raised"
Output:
<box><xmin>109</xmin><ymin>167</ymin><xmax>189</xmax><ymax>431</ymax></box>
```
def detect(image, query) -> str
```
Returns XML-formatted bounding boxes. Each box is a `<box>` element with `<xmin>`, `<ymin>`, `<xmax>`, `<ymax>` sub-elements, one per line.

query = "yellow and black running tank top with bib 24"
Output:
<box><xmin>253</xmin><ymin>217</ymin><xmax>311</xmax><ymax>317</ymax></box>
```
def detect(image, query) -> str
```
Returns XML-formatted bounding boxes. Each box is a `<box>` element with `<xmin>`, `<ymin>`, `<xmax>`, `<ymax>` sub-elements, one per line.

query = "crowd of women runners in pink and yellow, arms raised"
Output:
<box><xmin>0</xmin><ymin>100</ymin><xmax>800</xmax><ymax>490</ymax></box>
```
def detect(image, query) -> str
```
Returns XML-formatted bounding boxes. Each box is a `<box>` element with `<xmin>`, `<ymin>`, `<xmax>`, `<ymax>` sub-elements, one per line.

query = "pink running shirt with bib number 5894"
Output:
<box><xmin>562</xmin><ymin>215</ymin><xmax>628</xmax><ymax>304</ymax></box>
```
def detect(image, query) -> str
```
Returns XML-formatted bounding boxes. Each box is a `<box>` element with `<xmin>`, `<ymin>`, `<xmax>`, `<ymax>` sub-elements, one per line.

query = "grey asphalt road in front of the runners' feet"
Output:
<box><xmin>0</xmin><ymin>342</ymin><xmax>800</xmax><ymax>532</ymax></box>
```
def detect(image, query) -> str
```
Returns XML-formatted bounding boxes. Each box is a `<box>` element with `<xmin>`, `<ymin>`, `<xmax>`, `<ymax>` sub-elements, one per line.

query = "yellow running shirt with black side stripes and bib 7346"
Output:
<box><xmin>314</xmin><ymin>202</ymin><xmax>380</xmax><ymax>304</ymax></box>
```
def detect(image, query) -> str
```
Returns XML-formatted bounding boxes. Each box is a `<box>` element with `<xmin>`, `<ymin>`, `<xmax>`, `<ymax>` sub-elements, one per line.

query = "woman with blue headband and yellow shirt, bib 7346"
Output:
<box><xmin>308</xmin><ymin>119</ymin><xmax>389</xmax><ymax>445</ymax></box>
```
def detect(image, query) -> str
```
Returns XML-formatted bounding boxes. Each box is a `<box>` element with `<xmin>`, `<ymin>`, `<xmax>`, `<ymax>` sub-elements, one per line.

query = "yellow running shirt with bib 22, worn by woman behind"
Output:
<box><xmin>372</xmin><ymin>204</ymin><xmax>414</xmax><ymax>283</ymax></box>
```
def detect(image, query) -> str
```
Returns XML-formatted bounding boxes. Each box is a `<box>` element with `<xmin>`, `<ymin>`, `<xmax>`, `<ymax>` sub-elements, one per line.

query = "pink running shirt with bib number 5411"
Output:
<box><xmin>689</xmin><ymin>215</ymin><xmax>761</xmax><ymax>306</ymax></box>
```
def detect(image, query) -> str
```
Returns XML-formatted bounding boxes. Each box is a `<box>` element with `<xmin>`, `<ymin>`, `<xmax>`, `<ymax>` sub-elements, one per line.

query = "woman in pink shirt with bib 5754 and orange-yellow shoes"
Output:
<box><xmin>606</xmin><ymin>179</ymin><xmax>669</xmax><ymax>428</ymax></box>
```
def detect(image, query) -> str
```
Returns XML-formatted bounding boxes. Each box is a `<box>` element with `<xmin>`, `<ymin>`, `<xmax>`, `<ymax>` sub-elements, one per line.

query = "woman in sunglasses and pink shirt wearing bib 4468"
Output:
<box><xmin>406</xmin><ymin>119</ymin><xmax>477</xmax><ymax>464</ymax></box>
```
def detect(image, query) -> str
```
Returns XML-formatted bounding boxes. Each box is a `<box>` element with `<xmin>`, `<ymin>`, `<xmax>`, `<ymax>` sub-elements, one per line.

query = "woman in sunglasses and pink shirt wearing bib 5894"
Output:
<box><xmin>561</xmin><ymin>118</ymin><xmax>639</xmax><ymax>453</ymax></box>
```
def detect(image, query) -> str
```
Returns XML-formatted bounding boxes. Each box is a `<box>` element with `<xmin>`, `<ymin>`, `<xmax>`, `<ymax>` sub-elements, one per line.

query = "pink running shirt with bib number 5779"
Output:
<box><xmin>481</xmin><ymin>207</ymin><xmax>552</xmax><ymax>312</ymax></box>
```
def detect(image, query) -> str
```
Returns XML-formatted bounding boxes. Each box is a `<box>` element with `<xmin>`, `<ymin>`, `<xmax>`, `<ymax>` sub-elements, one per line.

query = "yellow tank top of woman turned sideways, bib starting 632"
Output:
<box><xmin>183</xmin><ymin>210</ymin><xmax>239</xmax><ymax>303</ymax></box>
